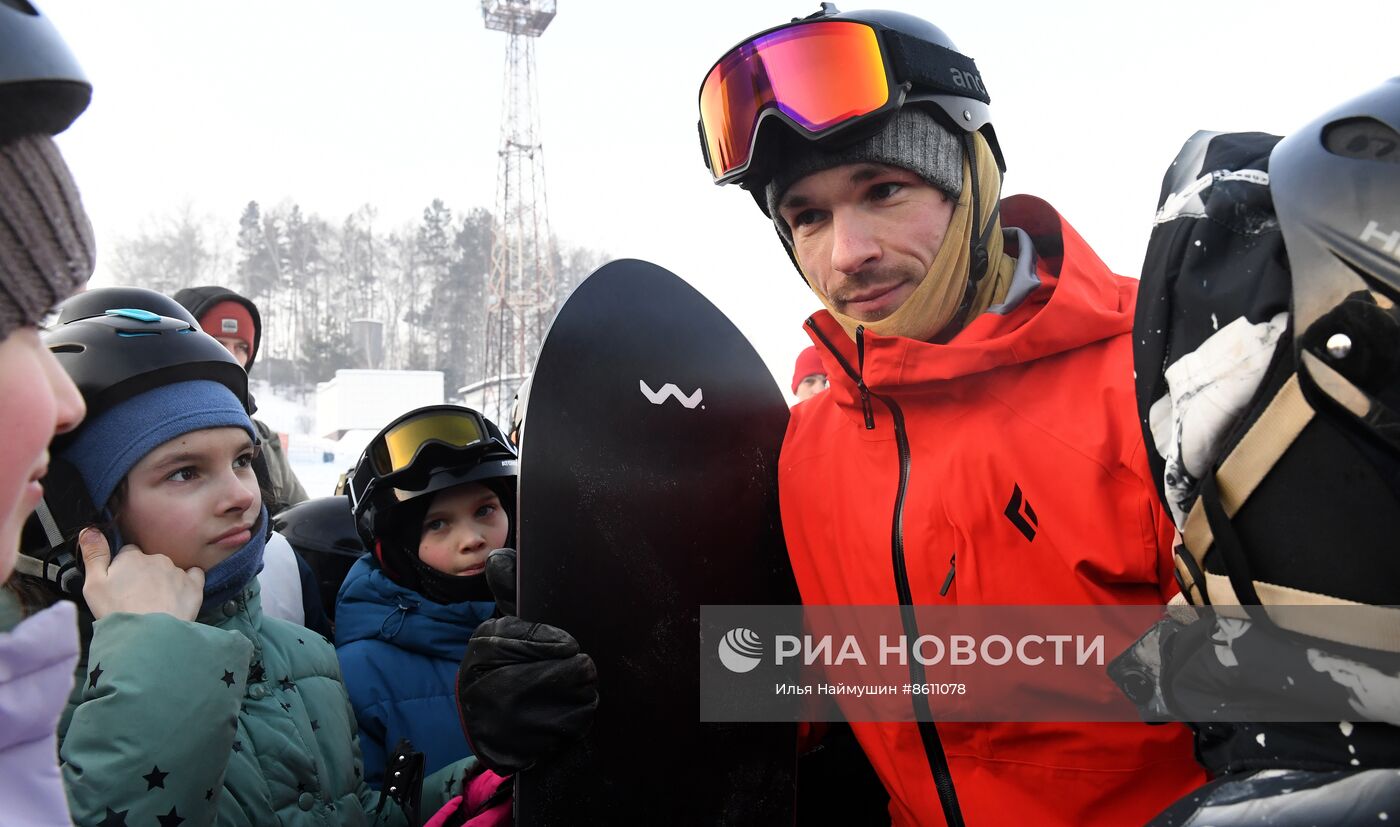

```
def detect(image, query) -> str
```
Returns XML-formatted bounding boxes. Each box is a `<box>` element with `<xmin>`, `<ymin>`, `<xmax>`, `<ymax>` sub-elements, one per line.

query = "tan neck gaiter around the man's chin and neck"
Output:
<box><xmin>806</xmin><ymin>133</ymin><xmax>1016</xmax><ymax>341</ymax></box>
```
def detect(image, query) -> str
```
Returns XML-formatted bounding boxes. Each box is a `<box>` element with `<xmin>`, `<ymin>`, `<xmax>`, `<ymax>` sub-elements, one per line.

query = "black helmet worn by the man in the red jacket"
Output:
<box><xmin>701</xmin><ymin>3</ymin><xmax>1007</xmax><ymax>204</ymax></box>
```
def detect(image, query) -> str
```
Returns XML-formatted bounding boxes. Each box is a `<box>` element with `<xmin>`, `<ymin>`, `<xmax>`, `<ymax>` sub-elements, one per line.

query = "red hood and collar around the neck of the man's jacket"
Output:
<box><xmin>806</xmin><ymin>196</ymin><xmax>1137</xmax><ymax>417</ymax></box>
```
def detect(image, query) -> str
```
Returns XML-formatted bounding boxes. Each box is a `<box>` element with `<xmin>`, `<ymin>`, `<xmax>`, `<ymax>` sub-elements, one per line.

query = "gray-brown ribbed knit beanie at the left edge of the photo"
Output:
<box><xmin>0</xmin><ymin>134</ymin><xmax>95</xmax><ymax>339</ymax></box>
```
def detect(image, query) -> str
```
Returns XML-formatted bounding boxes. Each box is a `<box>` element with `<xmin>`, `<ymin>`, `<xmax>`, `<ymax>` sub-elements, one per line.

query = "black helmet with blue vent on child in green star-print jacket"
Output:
<box><xmin>43</xmin><ymin>310</ymin><xmax>249</xmax><ymax>442</ymax></box>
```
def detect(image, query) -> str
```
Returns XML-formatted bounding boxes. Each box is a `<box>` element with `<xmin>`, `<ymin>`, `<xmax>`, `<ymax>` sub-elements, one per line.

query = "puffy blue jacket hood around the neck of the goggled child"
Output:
<box><xmin>336</xmin><ymin>554</ymin><xmax>496</xmax><ymax>660</ymax></box>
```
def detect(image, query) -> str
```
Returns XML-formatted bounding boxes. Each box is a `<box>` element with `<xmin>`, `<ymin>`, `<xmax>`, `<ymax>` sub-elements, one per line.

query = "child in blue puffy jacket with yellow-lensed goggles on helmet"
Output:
<box><xmin>336</xmin><ymin>404</ymin><xmax>517</xmax><ymax>785</ymax></box>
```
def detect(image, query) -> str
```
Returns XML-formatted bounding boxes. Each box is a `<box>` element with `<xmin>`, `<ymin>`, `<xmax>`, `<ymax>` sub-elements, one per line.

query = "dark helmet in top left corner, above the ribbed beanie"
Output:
<box><xmin>0</xmin><ymin>0</ymin><xmax>92</xmax><ymax>143</ymax></box>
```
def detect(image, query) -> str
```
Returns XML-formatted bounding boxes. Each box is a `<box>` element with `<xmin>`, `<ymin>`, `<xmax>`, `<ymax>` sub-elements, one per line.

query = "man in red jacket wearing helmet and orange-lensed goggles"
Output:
<box><xmin>688</xmin><ymin>3</ymin><xmax>1201</xmax><ymax>824</ymax></box>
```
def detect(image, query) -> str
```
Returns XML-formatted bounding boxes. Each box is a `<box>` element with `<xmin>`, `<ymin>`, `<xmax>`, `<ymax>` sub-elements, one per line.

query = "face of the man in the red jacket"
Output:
<box><xmin>778</xmin><ymin>164</ymin><xmax>956</xmax><ymax>322</ymax></box>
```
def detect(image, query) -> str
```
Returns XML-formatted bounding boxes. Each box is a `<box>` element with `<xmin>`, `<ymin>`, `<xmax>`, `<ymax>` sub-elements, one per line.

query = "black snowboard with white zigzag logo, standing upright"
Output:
<box><xmin>515</xmin><ymin>260</ymin><xmax>798</xmax><ymax>827</ymax></box>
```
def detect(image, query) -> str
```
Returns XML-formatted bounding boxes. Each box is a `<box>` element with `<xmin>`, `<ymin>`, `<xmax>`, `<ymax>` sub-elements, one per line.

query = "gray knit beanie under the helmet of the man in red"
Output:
<box><xmin>763</xmin><ymin>106</ymin><xmax>963</xmax><ymax>245</ymax></box>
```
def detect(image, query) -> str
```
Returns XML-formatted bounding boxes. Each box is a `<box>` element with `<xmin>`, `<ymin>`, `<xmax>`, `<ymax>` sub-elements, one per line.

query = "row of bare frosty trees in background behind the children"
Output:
<box><xmin>113</xmin><ymin>199</ymin><xmax>608</xmax><ymax>392</ymax></box>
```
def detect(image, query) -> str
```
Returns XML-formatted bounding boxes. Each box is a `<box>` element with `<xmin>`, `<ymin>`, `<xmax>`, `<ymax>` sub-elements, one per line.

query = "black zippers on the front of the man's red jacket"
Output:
<box><xmin>806</xmin><ymin>318</ymin><xmax>965</xmax><ymax>827</ymax></box>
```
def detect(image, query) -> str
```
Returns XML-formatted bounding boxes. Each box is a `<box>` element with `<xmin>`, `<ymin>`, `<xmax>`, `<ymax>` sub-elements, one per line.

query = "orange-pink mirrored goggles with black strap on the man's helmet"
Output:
<box><xmin>700</xmin><ymin>20</ymin><xmax>991</xmax><ymax>183</ymax></box>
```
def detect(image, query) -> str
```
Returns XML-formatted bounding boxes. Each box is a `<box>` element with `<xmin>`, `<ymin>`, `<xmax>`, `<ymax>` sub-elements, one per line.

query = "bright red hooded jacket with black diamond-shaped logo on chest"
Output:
<box><xmin>778</xmin><ymin>196</ymin><xmax>1204</xmax><ymax>827</ymax></box>
